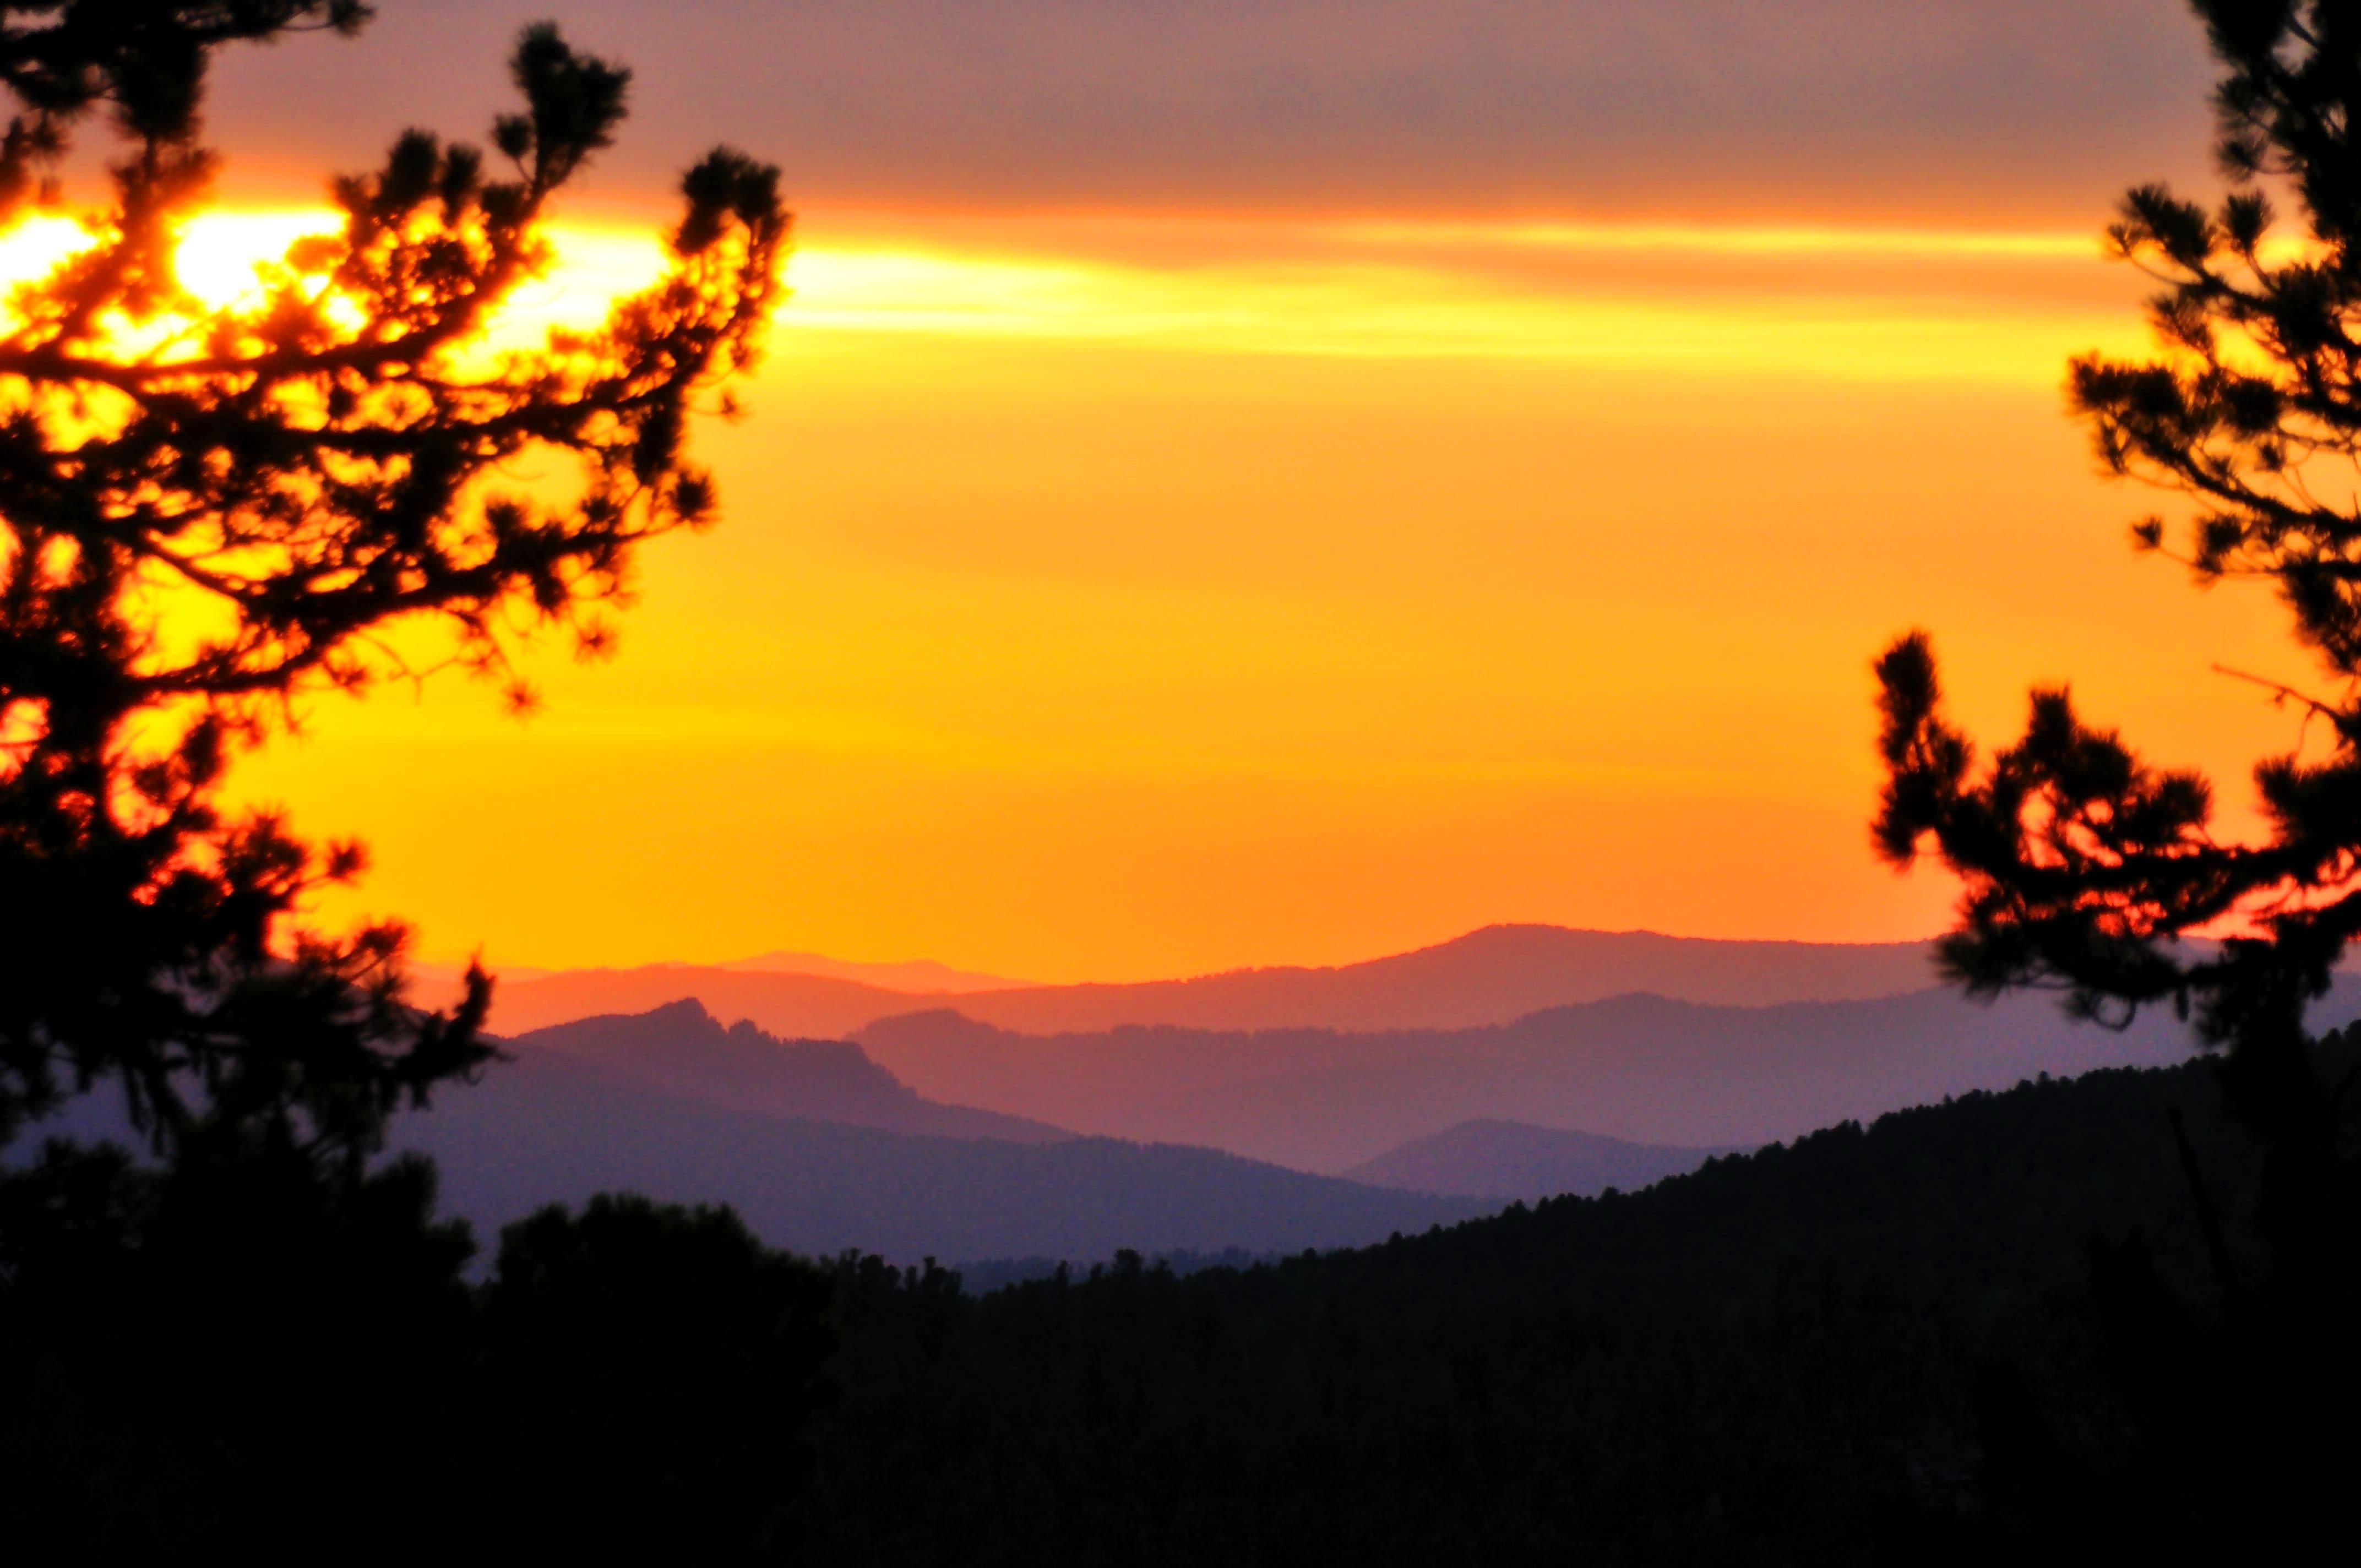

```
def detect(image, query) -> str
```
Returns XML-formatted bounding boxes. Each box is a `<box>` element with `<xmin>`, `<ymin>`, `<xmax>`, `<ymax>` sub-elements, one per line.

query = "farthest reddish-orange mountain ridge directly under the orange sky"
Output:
<box><xmin>460</xmin><ymin>925</ymin><xmax>1934</xmax><ymax>1039</ymax></box>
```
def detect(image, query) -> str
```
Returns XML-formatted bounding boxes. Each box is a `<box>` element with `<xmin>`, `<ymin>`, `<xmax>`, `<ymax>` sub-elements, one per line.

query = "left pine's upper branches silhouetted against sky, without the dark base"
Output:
<box><xmin>0</xmin><ymin>0</ymin><xmax>788</xmax><ymax>1159</ymax></box>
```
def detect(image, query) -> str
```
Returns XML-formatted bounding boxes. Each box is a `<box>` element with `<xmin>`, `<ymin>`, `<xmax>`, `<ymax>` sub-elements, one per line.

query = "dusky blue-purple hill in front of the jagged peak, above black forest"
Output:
<box><xmin>394</xmin><ymin>1048</ymin><xmax>1497</xmax><ymax>1261</ymax></box>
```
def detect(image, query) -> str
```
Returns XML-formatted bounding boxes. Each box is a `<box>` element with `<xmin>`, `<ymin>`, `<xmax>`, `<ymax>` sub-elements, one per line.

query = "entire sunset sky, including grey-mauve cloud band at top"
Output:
<box><xmin>69</xmin><ymin>0</ymin><xmax>2306</xmax><ymax>980</ymax></box>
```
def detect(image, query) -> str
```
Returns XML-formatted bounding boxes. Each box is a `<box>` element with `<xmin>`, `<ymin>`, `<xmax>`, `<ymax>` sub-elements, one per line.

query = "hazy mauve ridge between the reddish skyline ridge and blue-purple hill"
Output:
<box><xmin>857</xmin><ymin>980</ymin><xmax>2356</xmax><ymax>1171</ymax></box>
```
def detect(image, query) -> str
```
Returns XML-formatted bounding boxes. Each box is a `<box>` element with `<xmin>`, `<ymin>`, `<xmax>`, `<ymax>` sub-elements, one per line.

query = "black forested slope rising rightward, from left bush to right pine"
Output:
<box><xmin>793</xmin><ymin>1039</ymin><xmax>2361</xmax><ymax>1563</ymax></box>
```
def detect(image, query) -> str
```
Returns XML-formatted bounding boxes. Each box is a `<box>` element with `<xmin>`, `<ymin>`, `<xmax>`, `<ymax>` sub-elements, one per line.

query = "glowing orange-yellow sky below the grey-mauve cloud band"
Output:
<box><xmin>18</xmin><ymin>9</ymin><xmax>2306</xmax><ymax>980</ymax></box>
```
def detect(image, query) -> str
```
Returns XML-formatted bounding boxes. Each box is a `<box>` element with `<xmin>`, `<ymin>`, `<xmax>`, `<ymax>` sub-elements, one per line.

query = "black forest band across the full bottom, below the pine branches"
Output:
<box><xmin>0</xmin><ymin>1035</ymin><xmax>2361</xmax><ymax>1563</ymax></box>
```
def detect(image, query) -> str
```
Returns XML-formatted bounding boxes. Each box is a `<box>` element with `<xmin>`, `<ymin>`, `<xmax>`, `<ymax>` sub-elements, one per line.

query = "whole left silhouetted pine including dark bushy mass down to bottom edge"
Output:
<box><xmin>0</xmin><ymin>0</ymin><xmax>824</xmax><ymax>1563</ymax></box>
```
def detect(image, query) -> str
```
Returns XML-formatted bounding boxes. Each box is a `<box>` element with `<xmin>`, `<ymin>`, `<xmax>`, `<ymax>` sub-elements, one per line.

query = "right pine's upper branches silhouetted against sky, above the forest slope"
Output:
<box><xmin>1875</xmin><ymin>0</ymin><xmax>2361</xmax><ymax>1138</ymax></box>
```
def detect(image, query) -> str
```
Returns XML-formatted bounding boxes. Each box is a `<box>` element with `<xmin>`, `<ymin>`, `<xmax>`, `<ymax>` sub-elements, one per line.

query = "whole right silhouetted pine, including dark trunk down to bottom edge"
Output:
<box><xmin>1875</xmin><ymin>0</ymin><xmax>2361</xmax><ymax>1549</ymax></box>
